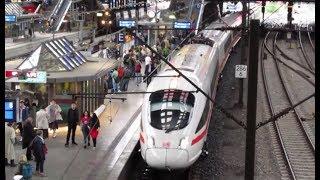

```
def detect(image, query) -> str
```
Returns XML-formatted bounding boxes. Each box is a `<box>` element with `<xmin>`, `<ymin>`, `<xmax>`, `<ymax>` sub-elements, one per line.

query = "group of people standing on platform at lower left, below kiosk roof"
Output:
<box><xmin>5</xmin><ymin>99</ymin><xmax>100</xmax><ymax>179</ymax></box>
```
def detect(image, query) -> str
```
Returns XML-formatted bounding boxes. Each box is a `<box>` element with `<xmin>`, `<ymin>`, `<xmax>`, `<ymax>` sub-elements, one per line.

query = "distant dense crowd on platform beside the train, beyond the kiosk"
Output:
<box><xmin>105</xmin><ymin>36</ymin><xmax>174</xmax><ymax>93</ymax></box>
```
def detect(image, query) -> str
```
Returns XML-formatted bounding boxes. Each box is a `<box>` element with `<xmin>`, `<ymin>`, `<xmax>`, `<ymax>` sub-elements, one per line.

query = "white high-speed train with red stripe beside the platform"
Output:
<box><xmin>140</xmin><ymin>13</ymin><xmax>241</xmax><ymax>169</ymax></box>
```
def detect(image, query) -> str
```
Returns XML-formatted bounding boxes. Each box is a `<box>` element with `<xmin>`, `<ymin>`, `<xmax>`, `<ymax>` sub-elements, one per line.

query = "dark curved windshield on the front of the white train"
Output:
<box><xmin>149</xmin><ymin>90</ymin><xmax>195</xmax><ymax>133</ymax></box>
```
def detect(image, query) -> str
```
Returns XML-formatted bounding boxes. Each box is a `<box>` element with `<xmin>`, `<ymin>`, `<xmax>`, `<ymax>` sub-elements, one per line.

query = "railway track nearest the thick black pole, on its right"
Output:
<box><xmin>261</xmin><ymin>33</ymin><xmax>315</xmax><ymax>179</ymax></box>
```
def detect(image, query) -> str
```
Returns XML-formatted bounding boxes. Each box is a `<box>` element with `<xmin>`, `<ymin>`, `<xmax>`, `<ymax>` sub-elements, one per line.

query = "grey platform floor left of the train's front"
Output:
<box><xmin>5</xmin><ymin>80</ymin><xmax>146</xmax><ymax>180</ymax></box>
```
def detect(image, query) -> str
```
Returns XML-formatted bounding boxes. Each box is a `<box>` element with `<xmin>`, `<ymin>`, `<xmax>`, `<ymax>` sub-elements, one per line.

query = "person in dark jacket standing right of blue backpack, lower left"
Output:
<box><xmin>31</xmin><ymin>130</ymin><xmax>48</xmax><ymax>177</ymax></box>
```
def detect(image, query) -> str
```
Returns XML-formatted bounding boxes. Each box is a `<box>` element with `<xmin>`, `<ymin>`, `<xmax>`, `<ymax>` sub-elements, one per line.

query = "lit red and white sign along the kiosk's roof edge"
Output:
<box><xmin>5</xmin><ymin>70</ymin><xmax>47</xmax><ymax>83</ymax></box>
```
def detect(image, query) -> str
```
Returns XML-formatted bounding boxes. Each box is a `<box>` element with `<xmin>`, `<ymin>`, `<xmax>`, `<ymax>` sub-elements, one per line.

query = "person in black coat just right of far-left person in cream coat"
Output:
<box><xmin>22</xmin><ymin>117</ymin><xmax>35</xmax><ymax>161</ymax></box>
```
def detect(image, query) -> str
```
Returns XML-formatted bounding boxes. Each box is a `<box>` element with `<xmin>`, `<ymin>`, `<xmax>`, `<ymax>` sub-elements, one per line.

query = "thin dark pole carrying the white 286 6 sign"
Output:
<box><xmin>238</xmin><ymin>1</ymin><xmax>247</xmax><ymax>108</ymax></box>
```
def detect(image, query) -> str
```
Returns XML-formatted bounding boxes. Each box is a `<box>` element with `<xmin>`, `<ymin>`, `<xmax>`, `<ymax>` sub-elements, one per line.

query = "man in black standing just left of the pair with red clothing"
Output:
<box><xmin>65</xmin><ymin>103</ymin><xmax>79</xmax><ymax>147</ymax></box>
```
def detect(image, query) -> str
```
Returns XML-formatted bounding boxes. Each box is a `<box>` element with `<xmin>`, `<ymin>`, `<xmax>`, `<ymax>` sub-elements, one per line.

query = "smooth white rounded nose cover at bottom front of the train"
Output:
<box><xmin>145</xmin><ymin>148</ymin><xmax>189</xmax><ymax>169</ymax></box>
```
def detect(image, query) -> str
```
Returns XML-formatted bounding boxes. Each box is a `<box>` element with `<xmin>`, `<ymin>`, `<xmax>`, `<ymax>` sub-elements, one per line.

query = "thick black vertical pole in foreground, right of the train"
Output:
<box><xmin>245</xmin><ymin>19</ymin><xmax>260</xmax><ymax>180</ymax></box>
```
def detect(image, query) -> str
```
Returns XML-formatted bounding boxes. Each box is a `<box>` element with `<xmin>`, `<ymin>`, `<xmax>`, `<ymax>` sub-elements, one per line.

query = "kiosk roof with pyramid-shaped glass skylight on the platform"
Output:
<box><xmin>5</xmin><ymin>37</ymin><xmax>118</xmax><ymax>83</ymax></box>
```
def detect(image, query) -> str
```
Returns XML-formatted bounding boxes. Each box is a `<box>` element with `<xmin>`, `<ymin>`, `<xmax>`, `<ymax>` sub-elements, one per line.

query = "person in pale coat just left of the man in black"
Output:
<box><xmin>46</xmin><ymin>100</ymin><xmax>62</xmax><ymax>138</ymax></box>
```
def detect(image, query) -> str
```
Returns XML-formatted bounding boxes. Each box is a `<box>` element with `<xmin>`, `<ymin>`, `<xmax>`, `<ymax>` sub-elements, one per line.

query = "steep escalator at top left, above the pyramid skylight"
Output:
<box><xmin>50</xmin><ymin>0</ymin><xmax>72</xmax><ymax>31</ymax></box>
